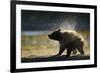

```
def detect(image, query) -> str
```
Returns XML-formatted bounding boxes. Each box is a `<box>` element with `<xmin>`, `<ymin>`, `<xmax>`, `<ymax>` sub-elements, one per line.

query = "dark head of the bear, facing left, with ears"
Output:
<box><xmin>48</xmin><ymin>29</ymin><xmax>62</xmax><ymax>41</ymax></box>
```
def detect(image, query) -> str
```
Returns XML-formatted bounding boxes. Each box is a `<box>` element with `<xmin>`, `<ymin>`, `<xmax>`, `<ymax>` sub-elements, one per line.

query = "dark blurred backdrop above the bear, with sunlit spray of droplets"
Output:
<box><xmin>21</xmin><ymin>10</ymin><xmax>90</xmax><ymax>31</ymax></box>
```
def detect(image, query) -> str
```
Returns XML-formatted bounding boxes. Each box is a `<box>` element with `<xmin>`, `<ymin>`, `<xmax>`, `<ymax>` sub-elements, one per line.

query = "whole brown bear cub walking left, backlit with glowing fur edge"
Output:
<box><xmin>48</xmin><ymin>29</ymin><xmax>84</xmax><ymax>57</ymax></box>
